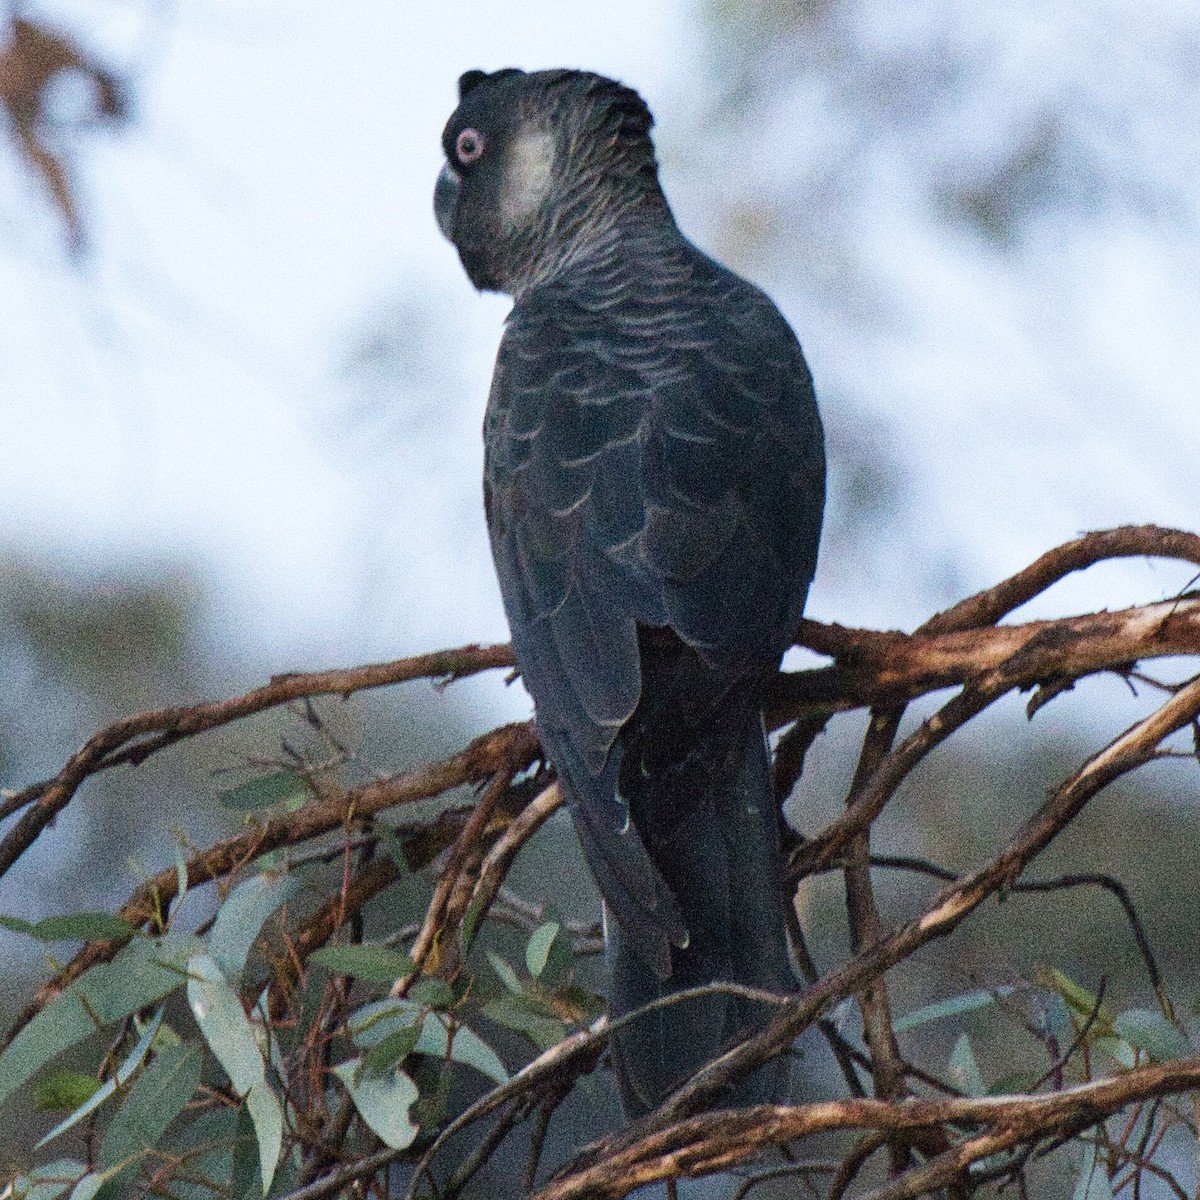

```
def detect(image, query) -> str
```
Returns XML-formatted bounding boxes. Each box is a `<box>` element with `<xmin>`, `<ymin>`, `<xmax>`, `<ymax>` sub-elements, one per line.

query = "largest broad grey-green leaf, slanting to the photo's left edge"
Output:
<box><xmin>0</xmin><ymin>935</ymin><xmax>197</xmax><ymax>1104</ymax></box>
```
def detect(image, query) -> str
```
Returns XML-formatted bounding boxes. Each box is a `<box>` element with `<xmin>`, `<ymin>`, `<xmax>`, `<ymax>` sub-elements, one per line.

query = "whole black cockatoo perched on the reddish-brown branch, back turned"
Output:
<box><xmin>434</xmin><ymin>70</ymin><xmax>824</xmax><ymax>1115</ymax></box>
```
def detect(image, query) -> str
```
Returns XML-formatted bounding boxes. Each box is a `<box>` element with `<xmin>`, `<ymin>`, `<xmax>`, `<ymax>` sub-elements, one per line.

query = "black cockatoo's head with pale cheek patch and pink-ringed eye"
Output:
<box><xmin>433</xmin><ymin>67</ymin><xmax>670</xmax><ymax>295</ymax></box>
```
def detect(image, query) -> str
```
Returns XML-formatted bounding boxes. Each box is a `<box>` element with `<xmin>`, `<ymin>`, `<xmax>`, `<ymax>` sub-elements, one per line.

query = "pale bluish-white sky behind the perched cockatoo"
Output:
<box><xmin>0</xmin><ymin>0</ymin><xmax>1200</xmax><ymax>724</ymax></box>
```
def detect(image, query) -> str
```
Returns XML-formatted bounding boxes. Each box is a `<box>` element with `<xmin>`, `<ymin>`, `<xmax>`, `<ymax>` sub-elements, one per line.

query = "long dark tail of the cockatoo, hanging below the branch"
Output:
<box><xmin>607</xmin><ymin>712</ymin><xmax>796</xmax><ymax>1117</ymax></box>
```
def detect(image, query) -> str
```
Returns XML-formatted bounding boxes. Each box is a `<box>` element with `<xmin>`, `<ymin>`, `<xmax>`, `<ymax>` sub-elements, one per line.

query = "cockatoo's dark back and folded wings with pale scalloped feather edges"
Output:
<box><xmin>485</xmin><ymin>254</ymin><xmax>824</xmax><ymax>954</ymax></box>
